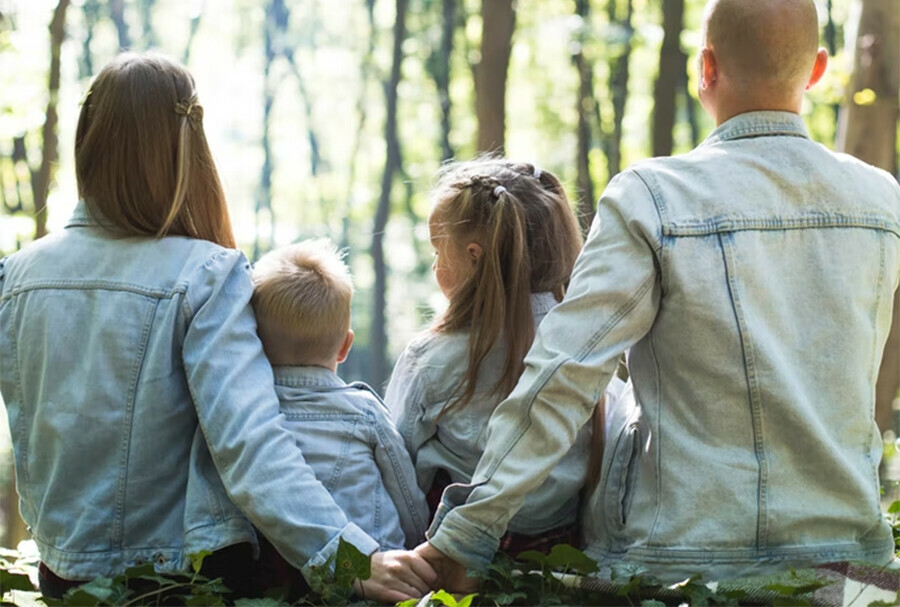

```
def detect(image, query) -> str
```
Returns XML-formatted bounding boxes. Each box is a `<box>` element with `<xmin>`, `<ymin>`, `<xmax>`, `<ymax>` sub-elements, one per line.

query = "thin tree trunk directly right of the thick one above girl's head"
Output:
<box><xmin>572</xmin><ymin>0</ymin><xmax>597</xmax><ymax>234</ymax></box>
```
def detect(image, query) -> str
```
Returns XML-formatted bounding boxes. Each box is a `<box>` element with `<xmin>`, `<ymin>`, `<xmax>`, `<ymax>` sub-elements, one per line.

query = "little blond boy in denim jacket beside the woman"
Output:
<box><xmin>252</xmin><ymin>239</ymin><xmax>428</xmax><ymax>550</ymax></box>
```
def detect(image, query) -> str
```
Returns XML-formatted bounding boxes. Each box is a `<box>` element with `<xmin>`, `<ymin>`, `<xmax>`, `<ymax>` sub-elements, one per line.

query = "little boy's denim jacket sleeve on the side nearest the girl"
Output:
<box><xmin>374</xmin><ymin>402</ymin><xmax>428</xmax><ymax>548</ymax></box>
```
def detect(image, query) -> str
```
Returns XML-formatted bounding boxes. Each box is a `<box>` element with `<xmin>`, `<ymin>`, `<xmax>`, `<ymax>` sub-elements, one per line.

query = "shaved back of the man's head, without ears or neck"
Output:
<box><xmin>704</xmin><ymin>0</ymin><xmax>819</xmax><ymax>97</ymax></box>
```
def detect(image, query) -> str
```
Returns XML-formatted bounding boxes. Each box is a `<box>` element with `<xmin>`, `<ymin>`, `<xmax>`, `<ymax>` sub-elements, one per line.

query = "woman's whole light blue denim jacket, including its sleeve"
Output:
<box><xmin>0</xmin><ymin>203</ymin><xmax>378</xmax><ymax>580</ymax></box>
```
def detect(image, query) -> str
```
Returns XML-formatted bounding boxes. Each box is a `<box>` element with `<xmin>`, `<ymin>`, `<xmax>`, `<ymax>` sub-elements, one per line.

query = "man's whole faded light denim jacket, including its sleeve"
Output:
<box><xmin>430</xmin><ymin>112</ymin><xmax>900</xmax><ymax>580</ymax></box>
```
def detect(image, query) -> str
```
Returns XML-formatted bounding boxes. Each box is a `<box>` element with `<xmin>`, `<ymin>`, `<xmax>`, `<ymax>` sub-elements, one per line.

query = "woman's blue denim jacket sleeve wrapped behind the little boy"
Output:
<box><xmin>182</xmin><ymin>250</ymin><xmax>378</xmax><ymax>580</ymax></box>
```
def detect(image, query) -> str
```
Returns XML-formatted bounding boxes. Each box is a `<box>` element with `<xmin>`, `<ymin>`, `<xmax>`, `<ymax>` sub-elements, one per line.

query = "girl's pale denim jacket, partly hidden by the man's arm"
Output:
<box><xmin>385</xmin><ymin>293</ymin><xmax>624</xmax><ymax>535</ymax></box>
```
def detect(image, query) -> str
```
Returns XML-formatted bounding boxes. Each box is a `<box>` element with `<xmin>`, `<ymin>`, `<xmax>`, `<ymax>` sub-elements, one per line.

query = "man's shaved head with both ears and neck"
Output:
<box><xmin>700</xmin><ymin>0</ymin><xmax>827</xmax><ymax>124</ymax></box>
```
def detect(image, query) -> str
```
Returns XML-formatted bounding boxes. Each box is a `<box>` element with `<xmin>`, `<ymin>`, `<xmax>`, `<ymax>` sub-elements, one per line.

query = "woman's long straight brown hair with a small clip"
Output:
<box><xmin>75</xmin><ymin>53</ymin><xmax>234</xmax><ymax>247</ymax></box>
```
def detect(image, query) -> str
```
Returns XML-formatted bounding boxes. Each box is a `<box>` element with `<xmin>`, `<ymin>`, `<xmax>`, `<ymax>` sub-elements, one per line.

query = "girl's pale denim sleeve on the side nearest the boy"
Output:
<box><xmin>384</xmin><ymin>347</ymin><xmax>437</xmax><ymax>462</ymax></box>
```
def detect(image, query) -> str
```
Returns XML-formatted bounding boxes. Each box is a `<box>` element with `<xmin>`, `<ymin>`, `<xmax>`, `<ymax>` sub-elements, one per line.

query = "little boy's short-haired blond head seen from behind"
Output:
<box><xmin>252</xmin><ymin>238</ymin><xmax>353</xmax><ymax>365</ymax></box>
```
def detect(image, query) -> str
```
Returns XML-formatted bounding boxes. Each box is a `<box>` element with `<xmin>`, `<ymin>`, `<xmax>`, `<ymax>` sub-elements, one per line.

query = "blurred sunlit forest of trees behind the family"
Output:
<box><xmin>0</xmin><ymin>0</ymin><xmax>900</xmax><ymax>546</ymax></box>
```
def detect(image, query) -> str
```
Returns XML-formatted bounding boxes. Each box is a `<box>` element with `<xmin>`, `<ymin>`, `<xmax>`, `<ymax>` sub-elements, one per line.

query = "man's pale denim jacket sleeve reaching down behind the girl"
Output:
<box><xmin>429</xmin><ymin>171</ymin><xmax>661</xmax><ymax>570</ymax></box>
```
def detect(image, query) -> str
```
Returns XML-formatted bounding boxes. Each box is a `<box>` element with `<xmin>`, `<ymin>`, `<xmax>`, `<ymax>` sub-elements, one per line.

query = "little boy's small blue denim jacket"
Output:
<box><xmin>274</xmin><ymin>367</ymin><xmax>429</xmax><ymax>550</ymax></box>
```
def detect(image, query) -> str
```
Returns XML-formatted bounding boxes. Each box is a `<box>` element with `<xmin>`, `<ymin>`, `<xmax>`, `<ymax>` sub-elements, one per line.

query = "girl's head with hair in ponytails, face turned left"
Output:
<box><xmin>431</xmin><ymin>157</ymin><xmax>582</xmax><ymax>415</ymax></box>
